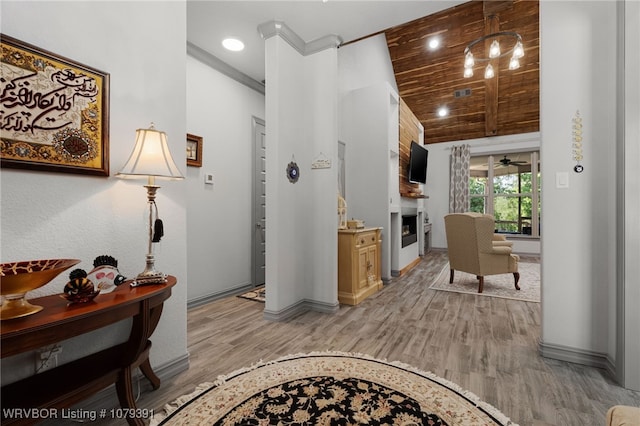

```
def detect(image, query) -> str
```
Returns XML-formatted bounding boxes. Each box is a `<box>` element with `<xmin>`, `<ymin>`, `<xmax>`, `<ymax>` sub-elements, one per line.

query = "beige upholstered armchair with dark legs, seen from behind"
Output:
<box><xmin>444</xmin><ymin>213</ymin><xmax>520</xmax><ymax>293</ymax></box>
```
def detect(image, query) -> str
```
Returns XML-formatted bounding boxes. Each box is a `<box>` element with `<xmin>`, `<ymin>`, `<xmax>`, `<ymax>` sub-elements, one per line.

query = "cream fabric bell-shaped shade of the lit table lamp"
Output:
<box><xmin>117</xmin><ymin>124</ymin><xmax>184</xmax><ymax>179</ymax></box>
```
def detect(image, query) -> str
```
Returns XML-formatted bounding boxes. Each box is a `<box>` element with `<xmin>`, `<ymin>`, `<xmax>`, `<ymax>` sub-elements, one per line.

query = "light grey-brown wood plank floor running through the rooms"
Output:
<box><xmin>131</xmin><ymin>250</ymin><xmax>640</xmax><ymax>426</ymax></box>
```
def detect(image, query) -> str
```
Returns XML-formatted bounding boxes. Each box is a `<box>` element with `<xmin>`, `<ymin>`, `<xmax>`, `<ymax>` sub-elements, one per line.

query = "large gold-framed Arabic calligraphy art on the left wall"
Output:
<box><xmin>0</xmin><ymin>34</ymin><xmax>109</xmax><ymax>176</ymax></box>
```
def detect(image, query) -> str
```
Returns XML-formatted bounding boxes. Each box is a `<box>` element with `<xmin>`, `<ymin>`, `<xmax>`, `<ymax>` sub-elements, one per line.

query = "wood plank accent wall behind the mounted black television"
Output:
<box><xmin>398</xmin><ymin>98</ymin><xmax>422</xmax><ymax>198</ymax></box>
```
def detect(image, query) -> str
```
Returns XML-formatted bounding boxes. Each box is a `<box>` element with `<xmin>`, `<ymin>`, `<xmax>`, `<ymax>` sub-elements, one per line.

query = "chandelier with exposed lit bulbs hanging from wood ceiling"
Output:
<box><xmin>463</xmin><ymin>31</ymin><xmax>524</xmax><ymax>78</ymax></box>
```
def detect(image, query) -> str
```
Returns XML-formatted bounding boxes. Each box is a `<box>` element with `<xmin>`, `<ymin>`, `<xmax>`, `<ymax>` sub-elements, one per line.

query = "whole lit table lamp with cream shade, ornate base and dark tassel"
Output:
<box><xmin>116</xmin><ymin>123</ymin><xmax>184</xmax><ymax>287</ymax></box>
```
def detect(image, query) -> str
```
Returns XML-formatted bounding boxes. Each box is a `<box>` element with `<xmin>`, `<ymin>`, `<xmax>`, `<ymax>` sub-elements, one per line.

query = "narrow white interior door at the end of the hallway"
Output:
<box><xmin>252</xmin><ymin>117</ymin><xmax>267</xmax><ymax>286</ymax></box>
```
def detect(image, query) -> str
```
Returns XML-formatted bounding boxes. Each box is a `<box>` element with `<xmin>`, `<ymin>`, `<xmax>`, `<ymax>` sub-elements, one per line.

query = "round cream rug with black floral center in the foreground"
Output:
<box><xmin>151</xmin><ymin>352</ymin><xmax>517</xmax><ymax>426</ymax></box>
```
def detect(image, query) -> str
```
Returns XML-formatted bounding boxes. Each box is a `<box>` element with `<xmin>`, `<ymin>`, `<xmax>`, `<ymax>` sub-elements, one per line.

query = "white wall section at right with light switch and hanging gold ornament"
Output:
<box><xmin>540</xmin><ymin>1</ymin><xmax>617</xmax><ymax>359</ymax></box>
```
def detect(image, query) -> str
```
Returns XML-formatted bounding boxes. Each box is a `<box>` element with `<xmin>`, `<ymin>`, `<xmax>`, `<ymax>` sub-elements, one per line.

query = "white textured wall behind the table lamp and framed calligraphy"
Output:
<box><xmin>0</xmin><ymin>1</ymin><xmax>187</xmax><ymax>384</ymax></box>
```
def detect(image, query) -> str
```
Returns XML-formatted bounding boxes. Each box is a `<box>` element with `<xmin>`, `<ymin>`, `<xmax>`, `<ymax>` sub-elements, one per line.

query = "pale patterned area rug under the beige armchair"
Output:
<box><xmin>429</xmin><ymin>262</ymin><xmax>540</xmax><ymax>302</ymax></box>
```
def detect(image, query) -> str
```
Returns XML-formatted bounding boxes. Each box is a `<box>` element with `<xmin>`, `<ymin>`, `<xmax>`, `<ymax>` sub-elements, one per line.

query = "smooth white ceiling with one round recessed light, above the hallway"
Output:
<box><xmin>187</xmin><ymin>0</ymin><xmax>465</xmax><ymax>81</ymax></box>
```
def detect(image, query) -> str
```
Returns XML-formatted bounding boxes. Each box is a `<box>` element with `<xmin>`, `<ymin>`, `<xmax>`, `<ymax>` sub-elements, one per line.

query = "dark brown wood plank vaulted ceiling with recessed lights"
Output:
<box><xmin>384</xmin><ymin>0</ymin><xmax>540</xmax><ymax>144</ymax></box>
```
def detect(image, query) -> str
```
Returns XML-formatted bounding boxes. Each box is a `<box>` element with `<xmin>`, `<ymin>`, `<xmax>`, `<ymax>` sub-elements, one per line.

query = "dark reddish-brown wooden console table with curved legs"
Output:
<box><xmin>1</xmin><ymin>276</ymin><xmax>176</xmax><ymax>425</ymax></box>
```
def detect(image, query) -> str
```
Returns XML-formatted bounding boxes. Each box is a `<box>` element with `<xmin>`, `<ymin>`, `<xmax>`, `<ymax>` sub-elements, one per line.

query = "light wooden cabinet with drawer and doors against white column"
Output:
<box><xmin>338</xmin><ymin>228</ymin><xmax>382</xmax><ymax>305</ymax></box>
